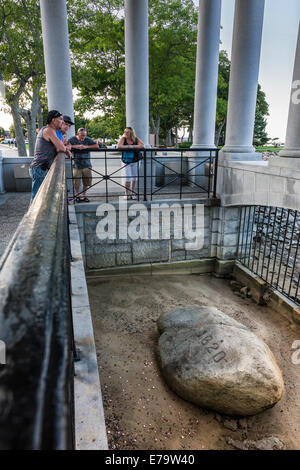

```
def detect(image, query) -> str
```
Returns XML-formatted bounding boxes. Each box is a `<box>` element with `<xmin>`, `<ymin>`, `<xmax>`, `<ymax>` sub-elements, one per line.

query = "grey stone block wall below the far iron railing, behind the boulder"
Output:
<box><xmin>76</xmin><ymin>199</ymin><xmax>240</xmax><ymax>271</ymax></box>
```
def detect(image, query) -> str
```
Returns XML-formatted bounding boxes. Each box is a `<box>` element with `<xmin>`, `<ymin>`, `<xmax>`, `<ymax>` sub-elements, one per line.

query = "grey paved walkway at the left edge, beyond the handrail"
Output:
<box><xmin>0</xmin><ymin>193</ymin><xmax>31</xmax><ymax>257</ymax></box>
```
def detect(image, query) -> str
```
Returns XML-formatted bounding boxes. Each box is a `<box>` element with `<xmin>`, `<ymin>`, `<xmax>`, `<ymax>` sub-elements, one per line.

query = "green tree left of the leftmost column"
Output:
<box><xmin>0</xmin><ymin>0</ymin><xmax>45</xmax><ymax>155</ymax></box>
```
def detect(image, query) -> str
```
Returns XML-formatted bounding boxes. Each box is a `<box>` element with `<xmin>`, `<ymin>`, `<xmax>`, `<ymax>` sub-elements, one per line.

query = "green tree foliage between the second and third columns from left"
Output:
<box><xmin>149</xmin><ymin>0</ymin><xmax>197</xmax><ymax>145</ymax></box>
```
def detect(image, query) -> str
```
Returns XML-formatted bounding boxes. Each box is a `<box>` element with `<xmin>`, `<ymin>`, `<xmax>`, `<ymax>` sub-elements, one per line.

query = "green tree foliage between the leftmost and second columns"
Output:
<box><xmin>68</xmin><ymin>0</ymin><xmax>126</xmax><ymax>137</ymax></box>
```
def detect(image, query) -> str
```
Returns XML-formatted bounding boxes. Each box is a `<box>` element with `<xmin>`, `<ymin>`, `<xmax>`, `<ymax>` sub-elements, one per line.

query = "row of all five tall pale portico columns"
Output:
<box><xmin>40</xmin><ymin>0</ymin><xmax>300</xmax><ymax>173</ymax></box>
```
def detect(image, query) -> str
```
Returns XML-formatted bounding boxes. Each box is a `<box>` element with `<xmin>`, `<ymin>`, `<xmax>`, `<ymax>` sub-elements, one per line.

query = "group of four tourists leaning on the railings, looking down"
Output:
<box><xmin>29</xmin><ymin>110</ymin><xmax>144</xmax><ymax>202</ymax></box>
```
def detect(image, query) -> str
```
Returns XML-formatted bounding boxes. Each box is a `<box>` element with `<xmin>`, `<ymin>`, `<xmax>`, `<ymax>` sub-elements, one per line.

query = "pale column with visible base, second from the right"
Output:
<box><xmin>222</xmin><ymin>0</ymin><xmax>265</xmax><ymax>160</ymax></box>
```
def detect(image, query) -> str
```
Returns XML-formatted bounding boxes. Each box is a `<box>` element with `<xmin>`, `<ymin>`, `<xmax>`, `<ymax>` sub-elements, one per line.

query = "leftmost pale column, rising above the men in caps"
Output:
<box><xmin>40</xmin><ymin>0</ymin><xmax>74</xmax><ymax>127</ymax></box>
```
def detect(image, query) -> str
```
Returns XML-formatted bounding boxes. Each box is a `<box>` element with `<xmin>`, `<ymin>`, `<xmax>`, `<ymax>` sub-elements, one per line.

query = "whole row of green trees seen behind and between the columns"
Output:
<box><xmin>0</xmin><ymin>0</ymin><xmax>268</xmax><ymax>149</ymax></box>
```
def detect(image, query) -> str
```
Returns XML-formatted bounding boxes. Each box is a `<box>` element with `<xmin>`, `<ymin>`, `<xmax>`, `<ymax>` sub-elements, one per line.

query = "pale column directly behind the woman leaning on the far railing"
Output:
<box><xmin>125</xmin><ymin>0</ymin><xmax>149</xmax><ymax>146</ymax></box>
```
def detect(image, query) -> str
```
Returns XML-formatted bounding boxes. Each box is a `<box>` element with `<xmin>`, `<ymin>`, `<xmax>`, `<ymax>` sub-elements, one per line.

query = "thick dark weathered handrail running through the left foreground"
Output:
<box><xmin>0</xmin><ymin>153</ymin><xmax>73</xmax><ymax>449</ymax></box>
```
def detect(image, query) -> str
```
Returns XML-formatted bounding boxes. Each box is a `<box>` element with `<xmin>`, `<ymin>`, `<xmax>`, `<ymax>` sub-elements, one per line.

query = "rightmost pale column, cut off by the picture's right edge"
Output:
<box><xmin>279</xmin><ymin>26</ymin><xmax>300</xmax><ymax>158</ymax></box>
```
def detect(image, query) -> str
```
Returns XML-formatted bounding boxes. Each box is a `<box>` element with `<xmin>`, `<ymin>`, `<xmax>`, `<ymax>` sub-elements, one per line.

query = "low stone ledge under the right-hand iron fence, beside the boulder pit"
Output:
<box><xmin>233</xmin><ymin>263</ymin><xmax>300</xmax><ymax>326</ymax></box>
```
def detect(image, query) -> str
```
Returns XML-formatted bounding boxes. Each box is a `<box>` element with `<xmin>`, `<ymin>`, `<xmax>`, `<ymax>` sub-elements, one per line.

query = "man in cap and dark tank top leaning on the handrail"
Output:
<box><xmin>29</xmin><ymin>109</ymin><xmax>67</xmax><ymax>203</ymax></box>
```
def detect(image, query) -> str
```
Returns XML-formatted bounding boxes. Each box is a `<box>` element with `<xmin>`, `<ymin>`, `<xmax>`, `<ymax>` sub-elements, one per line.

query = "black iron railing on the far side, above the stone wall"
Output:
<box><xmin>72</xmin><ymin>148</ymin><xmax>219</xmax><ymax>202</ymax></box>
